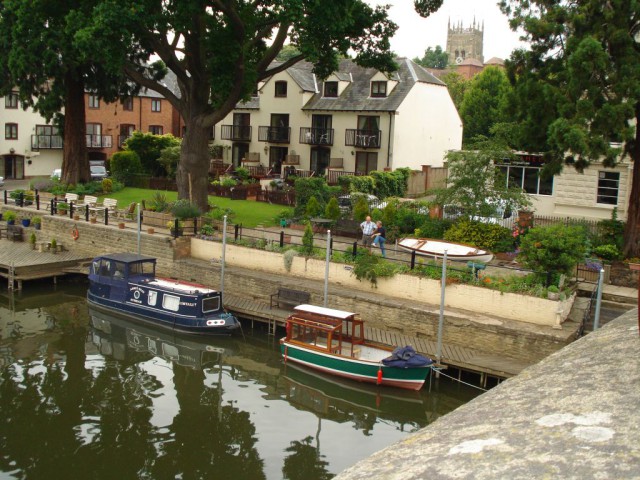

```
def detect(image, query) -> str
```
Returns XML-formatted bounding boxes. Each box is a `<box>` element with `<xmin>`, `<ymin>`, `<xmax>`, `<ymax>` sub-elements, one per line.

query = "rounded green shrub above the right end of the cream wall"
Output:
<box><xmin>518</xmin><ymin>225</ymin><xmax>587</xmax><ymax>275</ymax></box>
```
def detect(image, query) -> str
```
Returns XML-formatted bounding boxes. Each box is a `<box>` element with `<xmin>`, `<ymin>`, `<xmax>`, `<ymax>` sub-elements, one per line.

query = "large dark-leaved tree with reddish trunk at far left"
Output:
<box><xmin>0</xmin><ymin>0</ymin><xmax>133</xmax><ymax>183</ymax></box>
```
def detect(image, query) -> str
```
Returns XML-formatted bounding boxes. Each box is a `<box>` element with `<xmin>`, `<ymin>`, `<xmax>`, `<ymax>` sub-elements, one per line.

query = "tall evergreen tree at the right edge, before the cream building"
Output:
<box><xmin>501</xmin><ymin>0</ymin><xmax>640</xmax><ymax>256</ymax></box>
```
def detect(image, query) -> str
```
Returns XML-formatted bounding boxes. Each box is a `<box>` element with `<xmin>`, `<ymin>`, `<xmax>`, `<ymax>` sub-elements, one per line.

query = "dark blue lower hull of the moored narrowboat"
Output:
<box><xmin>87</xmin><ymin>291</ymin><xmax>240</xmax><ymax>335</ymax></box>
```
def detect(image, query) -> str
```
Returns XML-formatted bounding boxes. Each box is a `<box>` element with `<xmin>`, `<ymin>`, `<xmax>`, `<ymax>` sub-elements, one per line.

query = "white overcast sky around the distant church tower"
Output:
<box><xmin>366</xmin><ymin>0</ymin><xmax>522</xmax><ymax>61</ymax></box>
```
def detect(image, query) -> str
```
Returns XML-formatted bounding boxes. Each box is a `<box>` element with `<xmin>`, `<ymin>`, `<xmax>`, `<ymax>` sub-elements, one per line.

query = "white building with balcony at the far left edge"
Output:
<box><xmin>0</xmin><ymin>92</ymin><xmax>62</xmax><ymax>179</ymax></box>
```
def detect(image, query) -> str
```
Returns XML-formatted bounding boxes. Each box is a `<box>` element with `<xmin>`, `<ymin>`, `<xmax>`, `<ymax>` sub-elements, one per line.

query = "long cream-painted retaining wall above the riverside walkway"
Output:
<box><xmin>191</xmin><ymin>238</ymin><xmax>573</xmax><ymax>326</ymax></box>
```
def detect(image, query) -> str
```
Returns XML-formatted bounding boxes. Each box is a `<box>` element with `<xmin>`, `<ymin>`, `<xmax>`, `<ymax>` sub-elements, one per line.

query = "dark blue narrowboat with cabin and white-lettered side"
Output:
<box><xmin>87</xmin><ymin>253</ymin><xmax>240</xmax><ymax>334</ymax></box>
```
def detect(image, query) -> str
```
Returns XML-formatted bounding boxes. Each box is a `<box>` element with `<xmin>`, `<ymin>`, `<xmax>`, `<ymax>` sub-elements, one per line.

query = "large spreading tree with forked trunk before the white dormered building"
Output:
<box><xmin>88</xmin><ymin>0</ymin><xmax>441</xmax><ymax>208</ymax></box>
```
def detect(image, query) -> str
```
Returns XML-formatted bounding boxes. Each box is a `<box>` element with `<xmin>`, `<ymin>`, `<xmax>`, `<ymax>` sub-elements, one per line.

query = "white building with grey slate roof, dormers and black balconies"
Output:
<box><xmin>216</xmin><ymin>58</ymin><xmax>462</xmax><ymax>180</ymax></box>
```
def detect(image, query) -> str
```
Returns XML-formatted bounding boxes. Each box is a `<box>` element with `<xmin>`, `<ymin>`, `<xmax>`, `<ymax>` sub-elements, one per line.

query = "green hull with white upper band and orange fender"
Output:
<box><xmin>280</xmin><ymin>339</ymin><xmax>431</xmax><ymax>390</ymax></box>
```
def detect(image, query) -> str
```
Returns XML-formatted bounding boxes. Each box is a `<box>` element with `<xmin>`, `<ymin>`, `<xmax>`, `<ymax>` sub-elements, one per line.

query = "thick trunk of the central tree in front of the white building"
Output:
<box><xmin>176</xmin><ymin>117</ymin><xmax>211</xmax><ymax>212</ymax></box>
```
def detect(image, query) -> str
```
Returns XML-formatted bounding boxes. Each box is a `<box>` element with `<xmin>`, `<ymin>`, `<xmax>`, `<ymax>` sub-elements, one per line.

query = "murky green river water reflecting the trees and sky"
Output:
<box><xmin>0</xmin><ymin>280</ymin><xmax>479</xmax><ymax>480</ymax></box>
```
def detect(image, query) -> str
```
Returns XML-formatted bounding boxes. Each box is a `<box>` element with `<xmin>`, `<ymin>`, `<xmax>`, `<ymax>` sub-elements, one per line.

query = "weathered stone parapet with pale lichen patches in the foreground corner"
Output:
<box><xmin>335</xmin><ymin>310</ymin><xmax>640</xmax><ymax>480</ymax></box>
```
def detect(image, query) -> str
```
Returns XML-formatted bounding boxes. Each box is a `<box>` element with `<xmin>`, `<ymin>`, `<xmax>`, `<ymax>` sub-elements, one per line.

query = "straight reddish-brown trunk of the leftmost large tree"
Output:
<box><xmin>62</xmin><ymin>71</ymin><xmax>89</xmax><ymax>185</ymax></box>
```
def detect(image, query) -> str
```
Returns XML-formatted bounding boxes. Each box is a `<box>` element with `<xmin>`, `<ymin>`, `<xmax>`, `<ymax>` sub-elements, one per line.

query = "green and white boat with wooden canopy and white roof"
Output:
<box><xmin>280</xmin><ymin>305</ymin><xmax>433</xmax><ymax>390</ymax></box>
